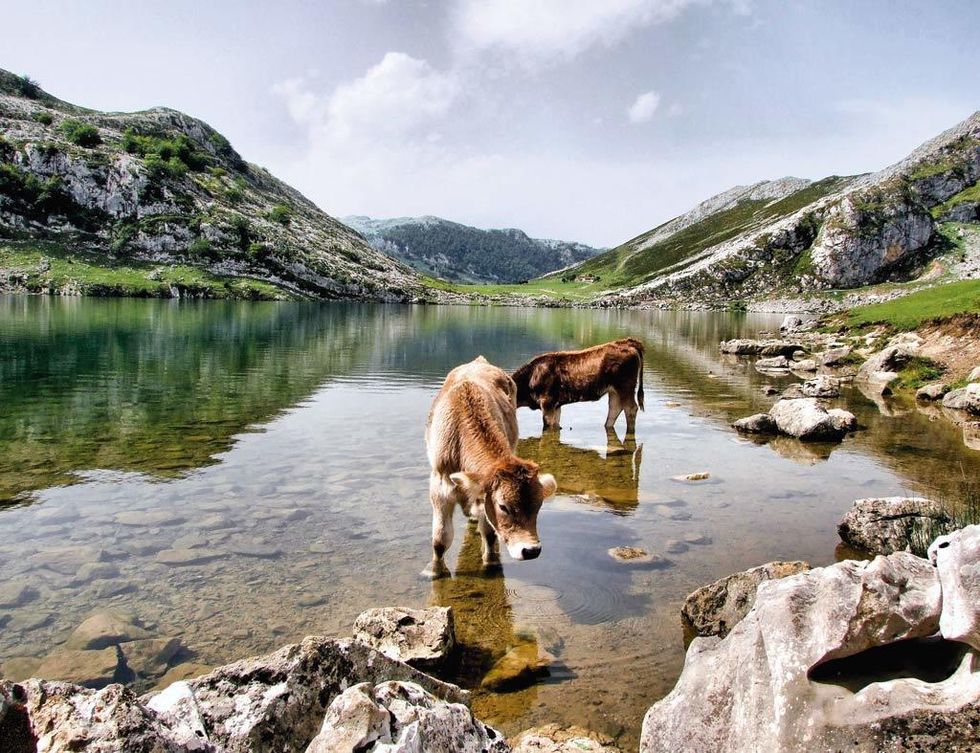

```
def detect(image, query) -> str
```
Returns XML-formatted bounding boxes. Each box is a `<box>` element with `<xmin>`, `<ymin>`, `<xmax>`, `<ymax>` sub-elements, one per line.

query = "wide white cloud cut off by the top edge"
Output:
<box><xmin>453</xmin><ymin>0</ymin><xmax>707</xmax><ymax>63</ymax></box>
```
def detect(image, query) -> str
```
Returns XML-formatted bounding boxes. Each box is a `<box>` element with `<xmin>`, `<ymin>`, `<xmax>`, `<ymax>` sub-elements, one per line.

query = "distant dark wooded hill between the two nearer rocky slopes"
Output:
<box><xmin>343</xmin><ymin>216</ymin><xmax>599</xmax><ymax>282</ymax></box>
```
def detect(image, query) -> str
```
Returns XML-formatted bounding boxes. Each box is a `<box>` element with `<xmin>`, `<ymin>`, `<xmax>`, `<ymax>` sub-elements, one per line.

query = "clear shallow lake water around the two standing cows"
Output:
<box><xmin>0</xmin><ymin>298</ymin><xmax>980</xmax><ymax>745</ymax></box>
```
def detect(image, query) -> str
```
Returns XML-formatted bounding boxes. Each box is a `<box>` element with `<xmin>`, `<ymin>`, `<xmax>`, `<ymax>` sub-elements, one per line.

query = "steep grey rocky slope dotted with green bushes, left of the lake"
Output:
<box><xmin>0</xmin><ymin>70</ymin><xmax>435</xmax><ymax>300</ymax></box>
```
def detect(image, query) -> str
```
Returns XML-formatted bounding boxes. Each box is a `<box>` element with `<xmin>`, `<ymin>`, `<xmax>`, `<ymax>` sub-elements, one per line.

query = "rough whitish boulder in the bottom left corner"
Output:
<box><xmin>0</xmin><ymin>680</ymin><xmax>180</xmax><ymax>753</ymax></box>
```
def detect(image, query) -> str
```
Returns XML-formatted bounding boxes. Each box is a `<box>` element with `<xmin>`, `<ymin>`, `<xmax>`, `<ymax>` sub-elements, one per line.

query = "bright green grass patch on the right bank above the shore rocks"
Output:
<box><xmin>846</xmin><ymin>280</ymin><xmax>980</xmax><ymax>331</ymax></box>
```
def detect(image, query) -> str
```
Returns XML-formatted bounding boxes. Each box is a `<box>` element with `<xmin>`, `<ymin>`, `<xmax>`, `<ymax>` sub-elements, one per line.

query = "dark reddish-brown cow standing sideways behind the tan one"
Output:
<box><xmin>512</xmin><ymin>337</ymin><xmax>644</xmax><ymax>434</ymax></box>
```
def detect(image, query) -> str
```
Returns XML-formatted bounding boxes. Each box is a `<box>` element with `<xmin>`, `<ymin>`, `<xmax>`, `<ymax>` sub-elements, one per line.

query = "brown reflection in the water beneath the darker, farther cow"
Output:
<box><xmin>517</xmin><ymin>429</ymin><xmax>643</xmax><ymax>513</ymax></box>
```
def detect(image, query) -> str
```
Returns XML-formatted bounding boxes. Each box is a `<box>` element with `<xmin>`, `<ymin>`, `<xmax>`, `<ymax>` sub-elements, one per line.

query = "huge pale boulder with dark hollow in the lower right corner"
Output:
<box><xmin>640</xmin><ymin>552</ymin><xmax>980</xmax><ymax>753</ymax></box>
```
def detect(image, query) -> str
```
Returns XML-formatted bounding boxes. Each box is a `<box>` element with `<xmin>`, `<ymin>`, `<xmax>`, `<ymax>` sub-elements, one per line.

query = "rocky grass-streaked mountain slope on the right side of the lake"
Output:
<box><xmin>565</xmin><ymin>112</ymin><xmax>980</xmax><ymax>305</ymax></box>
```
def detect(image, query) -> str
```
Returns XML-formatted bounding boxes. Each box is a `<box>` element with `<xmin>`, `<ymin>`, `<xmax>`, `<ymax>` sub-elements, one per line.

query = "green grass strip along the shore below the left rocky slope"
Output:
<box><xmin>0</xmin><ymin>242</ymin><xmax>292</xmax><ymax>300</ymax></box>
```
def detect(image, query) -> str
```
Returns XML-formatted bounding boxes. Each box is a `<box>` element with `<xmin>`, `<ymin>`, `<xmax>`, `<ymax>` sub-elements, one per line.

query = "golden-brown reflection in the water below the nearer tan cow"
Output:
<box><xmin>429</xmin><ymin>523</ymin><xmax>546</xmax><ymax>700</ymax></box>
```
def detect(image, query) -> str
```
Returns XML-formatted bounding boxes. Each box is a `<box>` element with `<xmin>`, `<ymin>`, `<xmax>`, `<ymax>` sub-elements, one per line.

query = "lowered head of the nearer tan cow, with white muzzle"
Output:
<box><xmin>449</xmin><ymin>458</ymin><xmax>558</xmax><ymax>560</ymax></box>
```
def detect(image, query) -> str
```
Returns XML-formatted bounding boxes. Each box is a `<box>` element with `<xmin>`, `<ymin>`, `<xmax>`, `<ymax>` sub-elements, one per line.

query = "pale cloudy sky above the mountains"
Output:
<box><xmin>0</xmin><ymin>0</ymin><xmax>980</xmax><ymax>246</ymax></box>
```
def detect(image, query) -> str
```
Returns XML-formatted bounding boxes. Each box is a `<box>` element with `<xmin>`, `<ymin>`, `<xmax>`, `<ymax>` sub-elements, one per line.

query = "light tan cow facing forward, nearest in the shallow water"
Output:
<box><xmin>424</xmin><ymin>356</ymin><xmax>558</xmax><ymax>578</ymax></box>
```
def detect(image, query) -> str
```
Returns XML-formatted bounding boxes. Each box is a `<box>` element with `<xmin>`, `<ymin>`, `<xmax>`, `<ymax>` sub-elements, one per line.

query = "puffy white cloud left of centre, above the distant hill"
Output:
<box><xmin>273</xmin><ymin>52</ymin><xmax>459</xmax><ymax>146</ymax></box>
